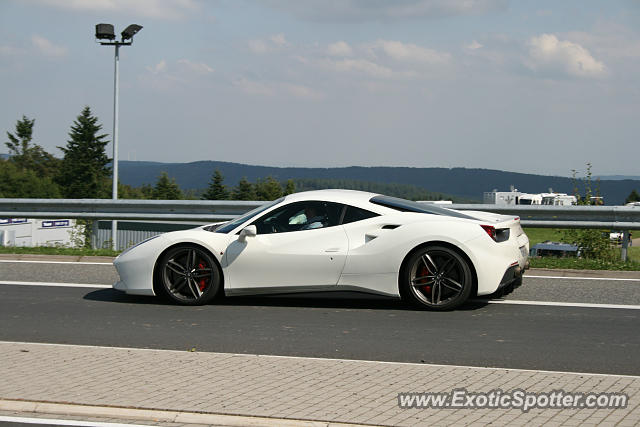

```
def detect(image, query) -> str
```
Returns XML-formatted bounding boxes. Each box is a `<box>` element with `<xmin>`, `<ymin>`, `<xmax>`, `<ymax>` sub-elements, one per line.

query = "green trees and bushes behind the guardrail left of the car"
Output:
<box><xmin>0</xmin><ymin>106</ymin><xmax>295</xmax><ymax>200</ymax></box>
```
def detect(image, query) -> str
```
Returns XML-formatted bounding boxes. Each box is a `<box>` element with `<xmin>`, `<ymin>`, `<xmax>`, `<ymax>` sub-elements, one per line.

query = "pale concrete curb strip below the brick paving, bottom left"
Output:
<box><xmin>0</xmin><ymin>399</ymin><xmax>365</xmax><ymax>427</ymax></box>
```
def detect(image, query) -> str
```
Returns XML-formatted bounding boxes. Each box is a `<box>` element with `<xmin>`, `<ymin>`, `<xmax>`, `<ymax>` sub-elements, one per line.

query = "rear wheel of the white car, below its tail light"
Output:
<box><xmin>400</xmin><ymin>245</ymin><xmax>473</xmax><ymax>311</ymax></box>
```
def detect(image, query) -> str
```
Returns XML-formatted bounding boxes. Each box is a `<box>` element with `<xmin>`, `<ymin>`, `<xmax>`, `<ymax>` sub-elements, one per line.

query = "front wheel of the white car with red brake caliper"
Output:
<box><xmin>156</xmin><ymin>244</ymin><xmax>222</xmax><ymax>305</ymax></box>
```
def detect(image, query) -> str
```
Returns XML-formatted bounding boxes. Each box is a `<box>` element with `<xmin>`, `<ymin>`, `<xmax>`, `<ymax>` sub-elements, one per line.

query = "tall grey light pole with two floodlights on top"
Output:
<box><xmin>96</xmin><ymin>24</ymin><xmax>142</xmax><ymax>251</ymax></box>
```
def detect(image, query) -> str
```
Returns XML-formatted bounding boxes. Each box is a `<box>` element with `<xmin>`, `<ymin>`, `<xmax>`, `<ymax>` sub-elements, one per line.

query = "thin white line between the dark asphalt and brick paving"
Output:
<box><xmin>0</xmin><ymin>341</ymin><xmax>640</xmax><ymax>379</ymax></box>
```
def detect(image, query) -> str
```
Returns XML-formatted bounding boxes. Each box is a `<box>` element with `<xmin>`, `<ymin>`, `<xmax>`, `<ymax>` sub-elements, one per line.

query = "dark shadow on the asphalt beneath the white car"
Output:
<box><xmin>83</xmin><ymin>289</ymin><xmax>488</xmax><ymax>311</ymax></box>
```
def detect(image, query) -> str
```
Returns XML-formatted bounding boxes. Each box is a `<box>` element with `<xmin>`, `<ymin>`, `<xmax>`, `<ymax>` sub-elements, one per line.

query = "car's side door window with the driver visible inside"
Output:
<box><xmin>253</xmin><ymin>201</ymin><xmax>342</xmax><ymax>234</ymax></box>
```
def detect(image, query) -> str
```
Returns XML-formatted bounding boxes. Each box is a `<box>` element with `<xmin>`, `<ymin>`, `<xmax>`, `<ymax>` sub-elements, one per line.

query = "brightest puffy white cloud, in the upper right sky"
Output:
<box><xmin>526</xmin><ymin>34</ymin><xmax>606</xmax><ymax>77</ymax></box>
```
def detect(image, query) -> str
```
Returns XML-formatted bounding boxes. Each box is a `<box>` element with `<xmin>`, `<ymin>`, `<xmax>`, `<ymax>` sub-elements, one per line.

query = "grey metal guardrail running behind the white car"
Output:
<box><xmin>0</xmin><ymin>199</ymin><xmax>640</xmax><ymax>259</ymax></box>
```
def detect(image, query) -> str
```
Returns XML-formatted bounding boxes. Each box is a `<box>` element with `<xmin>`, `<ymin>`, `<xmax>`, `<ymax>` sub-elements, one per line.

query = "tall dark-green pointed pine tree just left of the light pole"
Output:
<box><xmin>57</xmin><ymin>106</ymin><xmax>111</xmax><ymax>199</ymax></box>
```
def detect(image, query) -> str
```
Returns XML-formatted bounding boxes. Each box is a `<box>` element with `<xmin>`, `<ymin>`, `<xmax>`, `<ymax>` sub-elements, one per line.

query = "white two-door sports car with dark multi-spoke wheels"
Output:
<box><xmin>113</xmin><ymin>190</ymin><xmax>529</xmax><ymax>310</ymax></box>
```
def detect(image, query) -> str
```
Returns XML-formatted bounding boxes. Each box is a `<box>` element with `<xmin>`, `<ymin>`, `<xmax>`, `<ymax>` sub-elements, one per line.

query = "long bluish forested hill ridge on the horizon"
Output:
<box><xmin>119</xmin><ymin>161</ymin><xmax>640</xmax><ymax>205</ymax></box>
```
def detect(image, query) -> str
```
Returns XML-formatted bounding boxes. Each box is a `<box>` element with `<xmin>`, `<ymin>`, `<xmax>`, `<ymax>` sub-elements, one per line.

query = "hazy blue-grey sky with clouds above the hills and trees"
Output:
<box><xmin>0</xmin><ymin>0</ymin><xmax>640</xmax><ymax>176</ymax></box>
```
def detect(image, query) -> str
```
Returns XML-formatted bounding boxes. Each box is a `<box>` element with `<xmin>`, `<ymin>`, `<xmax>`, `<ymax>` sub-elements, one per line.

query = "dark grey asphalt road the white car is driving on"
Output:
<box><xmin>0</xmin><ymin>263</ymin><xmax>640</xmax><ymax>375</ymax></box>
